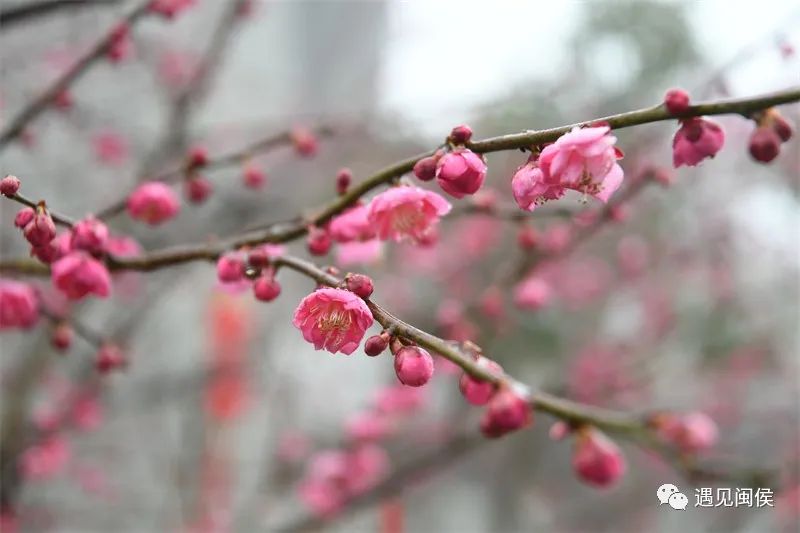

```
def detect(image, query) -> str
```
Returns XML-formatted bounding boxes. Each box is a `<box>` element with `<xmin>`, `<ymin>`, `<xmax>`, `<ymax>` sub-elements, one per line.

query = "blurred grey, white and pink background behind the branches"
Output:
<box><xmin>0</xmin><ymin>0</ymin><xmax>800</xmax><ymax>532</ymax></box>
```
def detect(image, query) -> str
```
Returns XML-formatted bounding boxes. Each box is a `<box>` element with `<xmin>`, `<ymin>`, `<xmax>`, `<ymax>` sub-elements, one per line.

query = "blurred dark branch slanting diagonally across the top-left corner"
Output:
<box><xmin>0</xmin><ymin>0</ymin><xmax>150</xmax><ymax>152</ymax></box>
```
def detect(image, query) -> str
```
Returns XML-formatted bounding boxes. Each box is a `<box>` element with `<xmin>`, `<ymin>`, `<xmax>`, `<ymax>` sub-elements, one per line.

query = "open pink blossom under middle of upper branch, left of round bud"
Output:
<box><xmin>367</xmin><ymin>186</ymin><xmax>452</xmax><ymax>242</ymax></box>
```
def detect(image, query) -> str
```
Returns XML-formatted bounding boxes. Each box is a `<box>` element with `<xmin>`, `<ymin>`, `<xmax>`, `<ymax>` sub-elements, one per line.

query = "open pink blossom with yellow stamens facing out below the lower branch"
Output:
<box><xmin>292</xmin><ymin>287</ymin><xmax>373</xmax><ymax>355</ymax></box>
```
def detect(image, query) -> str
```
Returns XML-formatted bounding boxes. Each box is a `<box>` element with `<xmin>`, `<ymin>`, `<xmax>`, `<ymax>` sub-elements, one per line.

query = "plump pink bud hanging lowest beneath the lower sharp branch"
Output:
<box><xmin>572</xmin><ymin>428</ymin><xmax>626</xmax><ymax>487</ymax></box>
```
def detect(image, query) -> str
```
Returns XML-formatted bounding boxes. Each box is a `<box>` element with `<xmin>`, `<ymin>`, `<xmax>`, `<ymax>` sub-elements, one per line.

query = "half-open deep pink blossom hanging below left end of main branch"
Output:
<box><xmin>51</xmin><ymin>251</ymin><xmax>111</xmax><ymax>300</ymax></box>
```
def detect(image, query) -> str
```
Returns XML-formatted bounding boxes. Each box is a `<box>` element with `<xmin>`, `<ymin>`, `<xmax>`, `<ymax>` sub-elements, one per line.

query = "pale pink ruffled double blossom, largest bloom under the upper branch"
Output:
<box><xmin>539</xmin><ymin>126</ymin><xmax>623</xmax><ymax>202</ymax></box>
